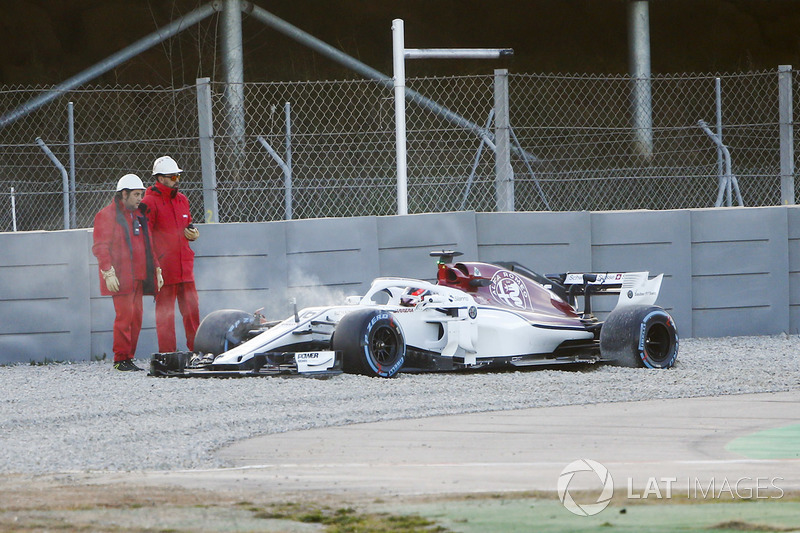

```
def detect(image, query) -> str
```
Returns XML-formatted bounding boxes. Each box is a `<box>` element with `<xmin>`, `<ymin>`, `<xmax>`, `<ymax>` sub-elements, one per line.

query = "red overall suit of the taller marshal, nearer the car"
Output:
<box><xmin>142</xmin><ymin>182</ymin><xmax>200</xmax><ymax>352</ymax></box>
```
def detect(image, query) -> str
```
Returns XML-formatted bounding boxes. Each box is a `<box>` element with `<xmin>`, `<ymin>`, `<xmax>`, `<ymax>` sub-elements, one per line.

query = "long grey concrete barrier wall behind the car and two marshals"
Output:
<box><xmin>0</xmin><ymin>207</ymin><xmax>800</xmax><ymax>363</ymax></box>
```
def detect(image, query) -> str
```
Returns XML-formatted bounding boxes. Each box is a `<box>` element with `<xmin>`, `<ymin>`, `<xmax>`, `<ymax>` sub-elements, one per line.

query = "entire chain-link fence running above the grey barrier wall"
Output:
<box><xmin>0</xmin><ymin>70</ymin><xmax>800</xmax><ymax>231</ymax></box>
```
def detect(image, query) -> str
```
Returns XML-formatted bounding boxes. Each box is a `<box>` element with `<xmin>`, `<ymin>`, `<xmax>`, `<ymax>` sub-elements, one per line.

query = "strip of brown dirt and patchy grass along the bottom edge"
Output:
<box><xmin>0</xmin><ymin>474</ymin><xmax>800</xmax><ymax>533</ymax></box>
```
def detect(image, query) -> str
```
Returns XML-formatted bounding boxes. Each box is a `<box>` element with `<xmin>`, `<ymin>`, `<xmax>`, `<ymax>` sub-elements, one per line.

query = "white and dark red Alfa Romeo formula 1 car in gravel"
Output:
<box><xmin>150</xmin><ymin>251</ymin><xmax>678</xmax><ymax>378</ymax></box>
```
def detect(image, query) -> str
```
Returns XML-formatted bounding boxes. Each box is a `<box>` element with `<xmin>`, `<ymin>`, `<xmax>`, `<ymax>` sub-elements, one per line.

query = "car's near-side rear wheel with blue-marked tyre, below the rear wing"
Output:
<box><xmin>600</xmin><ymin>305</ymin><xmax>678</xmax><ymax>368</ymax></box>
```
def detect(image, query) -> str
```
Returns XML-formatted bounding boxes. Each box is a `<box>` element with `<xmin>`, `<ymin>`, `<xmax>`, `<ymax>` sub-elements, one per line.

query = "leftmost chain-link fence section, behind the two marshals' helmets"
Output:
<box><xmin>0</xmin><ymin>87</ymin><xmax>202</xmax><ymax>231</ymax></box>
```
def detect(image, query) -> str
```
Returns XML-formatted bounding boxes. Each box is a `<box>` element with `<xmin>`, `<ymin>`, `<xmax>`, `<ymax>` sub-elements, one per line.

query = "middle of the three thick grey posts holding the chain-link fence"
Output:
<box><xmin>494</xmin><ymin>69</ymin><xmax>514</xmax><ymax>211</ymax></box>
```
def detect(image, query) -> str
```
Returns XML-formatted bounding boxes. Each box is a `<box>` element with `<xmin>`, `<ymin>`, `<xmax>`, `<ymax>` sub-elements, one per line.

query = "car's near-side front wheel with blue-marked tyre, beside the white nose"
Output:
<box><xmin>331</xmin><ymin>309</ymin><xmax>406</xmax><ymax>378</ymax></box>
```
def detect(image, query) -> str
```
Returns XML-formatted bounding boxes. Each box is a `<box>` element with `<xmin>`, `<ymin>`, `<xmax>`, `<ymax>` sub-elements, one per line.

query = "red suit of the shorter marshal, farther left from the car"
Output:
<box><xmin>92</xmin><ymin>200</ymin><xmax>159</xmax><ymax>363</ymax></box>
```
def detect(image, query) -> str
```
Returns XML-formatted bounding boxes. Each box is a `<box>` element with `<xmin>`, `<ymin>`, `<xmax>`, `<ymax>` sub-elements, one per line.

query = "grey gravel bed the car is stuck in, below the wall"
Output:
<box><xmin>0</xmin><ymin>335</ymin><xmax>800</xmax><ymax>474</ymax></box>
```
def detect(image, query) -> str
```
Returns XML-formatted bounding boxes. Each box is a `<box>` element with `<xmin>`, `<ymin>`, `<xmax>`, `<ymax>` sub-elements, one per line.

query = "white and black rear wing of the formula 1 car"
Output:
<box><xmin>547</xmin><ymin>272</ymin><xmax>664</xmax><ymax>315</ymax></box>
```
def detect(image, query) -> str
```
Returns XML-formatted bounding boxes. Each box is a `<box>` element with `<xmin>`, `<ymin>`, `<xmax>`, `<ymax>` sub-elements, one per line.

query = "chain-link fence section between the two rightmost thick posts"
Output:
<box><xmin>511</xmin><ymin>72</ymin><xmax>780</xmax><ymax>210</ymax></box>
